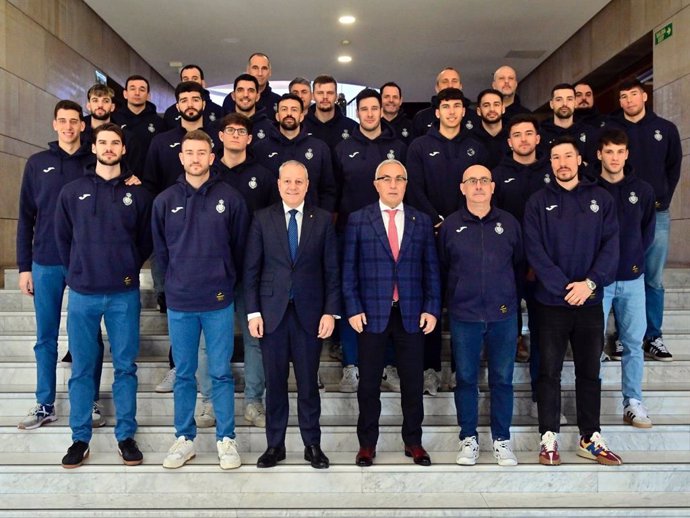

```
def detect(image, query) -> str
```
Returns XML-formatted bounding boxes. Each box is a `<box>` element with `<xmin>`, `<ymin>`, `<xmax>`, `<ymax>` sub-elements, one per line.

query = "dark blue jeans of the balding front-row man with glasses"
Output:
<box><xmin>450</xmin><ymin>315</ymin><xmax>517</xmax><ymax>441</ymax></box>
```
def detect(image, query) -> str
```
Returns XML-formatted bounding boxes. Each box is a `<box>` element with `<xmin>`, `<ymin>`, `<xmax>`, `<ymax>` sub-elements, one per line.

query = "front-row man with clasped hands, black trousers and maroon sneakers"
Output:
<box><xmin>523</xmin><ymin>137</ymin><xmax>622</xmax><ymax>465</ymax></box>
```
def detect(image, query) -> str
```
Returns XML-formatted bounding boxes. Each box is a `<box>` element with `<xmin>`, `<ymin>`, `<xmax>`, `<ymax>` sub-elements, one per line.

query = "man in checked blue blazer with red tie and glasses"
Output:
<box><xmin>343</xmin><ymin>160</ymin><xmax>441</xmax><ymax>466</ymax></box>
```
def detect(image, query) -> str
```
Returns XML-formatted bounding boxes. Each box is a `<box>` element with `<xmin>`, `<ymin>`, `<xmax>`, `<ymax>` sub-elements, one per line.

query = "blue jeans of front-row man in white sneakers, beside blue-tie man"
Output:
<box><xmin>168</xmin><ymin>304</ymin><xmax>235</xmax><ymax>440</ymax></box>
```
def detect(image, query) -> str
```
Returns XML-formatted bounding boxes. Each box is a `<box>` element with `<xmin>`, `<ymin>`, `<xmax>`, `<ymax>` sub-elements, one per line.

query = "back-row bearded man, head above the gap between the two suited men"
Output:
<box><xmin>304</xmin><ymin>75</ymin><xmax>357</xmax><ymax>153</ymax></box>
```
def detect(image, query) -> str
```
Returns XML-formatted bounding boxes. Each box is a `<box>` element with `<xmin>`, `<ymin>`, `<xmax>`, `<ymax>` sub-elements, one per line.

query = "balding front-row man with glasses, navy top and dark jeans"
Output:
<box><xmin>439</xmin><ymin>166</ymin><xmax>524</xmax><ymax>466</ymax></box>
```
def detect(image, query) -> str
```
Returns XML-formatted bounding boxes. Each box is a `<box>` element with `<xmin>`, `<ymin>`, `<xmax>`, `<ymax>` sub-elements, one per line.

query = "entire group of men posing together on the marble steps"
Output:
<box><xmin>17</xmin><ymin>53</ymin><xmax>681</xmax><ymax>469</ymax></box>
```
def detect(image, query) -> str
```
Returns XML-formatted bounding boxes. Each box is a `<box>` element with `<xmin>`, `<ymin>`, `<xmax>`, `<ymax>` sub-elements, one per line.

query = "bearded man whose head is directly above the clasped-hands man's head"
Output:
<box><xmin>539</xmin><ymin>83</ymin><xmax>596</xmax><ymax>167</ymax></box>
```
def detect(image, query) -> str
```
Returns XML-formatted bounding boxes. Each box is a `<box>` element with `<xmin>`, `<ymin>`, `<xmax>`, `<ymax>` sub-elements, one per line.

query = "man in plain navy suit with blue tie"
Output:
<box><xmin>244</xmin><ymin>160</ymin><xmax>340</xmax><ymax>469</ymax></box>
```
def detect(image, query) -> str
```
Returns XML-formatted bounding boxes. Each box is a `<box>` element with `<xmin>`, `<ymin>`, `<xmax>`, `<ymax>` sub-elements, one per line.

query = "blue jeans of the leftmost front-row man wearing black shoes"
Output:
<box><xmin>67</xmin><ymin>289</ymin><xmax>141</xmax><ymax>442</ymax></box>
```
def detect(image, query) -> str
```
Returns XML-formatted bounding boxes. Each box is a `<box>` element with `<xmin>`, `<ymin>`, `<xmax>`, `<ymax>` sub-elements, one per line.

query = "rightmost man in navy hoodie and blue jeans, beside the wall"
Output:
<box><xmin>611</xmin><ymin>81</ymin><xmax>683</xmax><ymax>361</ymax></box>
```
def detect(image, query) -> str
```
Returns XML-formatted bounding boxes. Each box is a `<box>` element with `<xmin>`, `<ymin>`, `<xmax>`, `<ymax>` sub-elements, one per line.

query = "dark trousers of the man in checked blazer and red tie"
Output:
<box><xmin>357</xmin><ymin>308</ymin><xmax>424</xmax><ymax>447</ymax></box>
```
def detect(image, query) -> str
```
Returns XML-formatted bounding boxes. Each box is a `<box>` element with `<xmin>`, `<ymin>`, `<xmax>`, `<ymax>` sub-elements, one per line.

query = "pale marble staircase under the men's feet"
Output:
<box><xmin>0</xmin><ymin>269</ymin><xmax>690</xmax><ymax>517</ymax></box>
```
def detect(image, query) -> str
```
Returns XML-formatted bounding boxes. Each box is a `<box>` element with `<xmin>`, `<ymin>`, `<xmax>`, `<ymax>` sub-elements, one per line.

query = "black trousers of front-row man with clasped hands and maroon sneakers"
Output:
<box><xmin>537</xmin><ymin>302</ymin><xmax>604</xmax><ymax>437</ymax></box>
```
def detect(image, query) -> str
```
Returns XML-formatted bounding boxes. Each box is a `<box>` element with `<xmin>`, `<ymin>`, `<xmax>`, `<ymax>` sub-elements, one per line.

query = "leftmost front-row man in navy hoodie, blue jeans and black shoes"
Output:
<box><xmin>55</xmin><ymin>123</ymin><xmax>153</xmax><ymax>468</ymax></box>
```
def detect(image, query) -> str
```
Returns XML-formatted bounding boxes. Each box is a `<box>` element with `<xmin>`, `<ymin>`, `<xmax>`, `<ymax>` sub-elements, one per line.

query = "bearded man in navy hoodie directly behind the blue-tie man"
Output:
<box><xmin>253</xmin><ymin>94</ymin><xmax>336</xmax><ymax>212</ymax></box>
